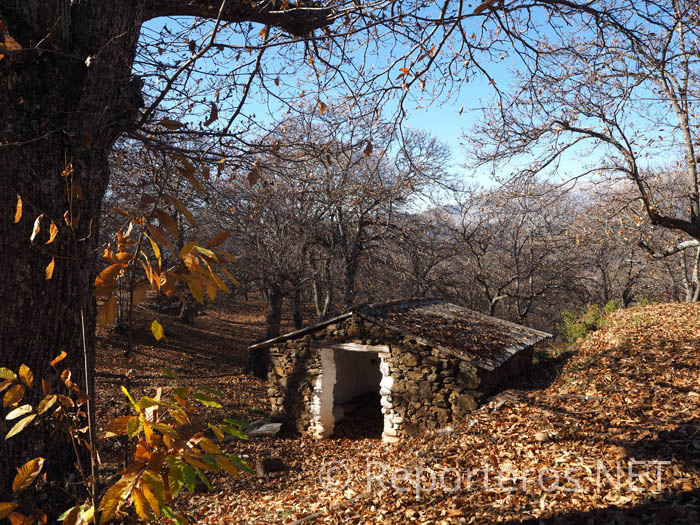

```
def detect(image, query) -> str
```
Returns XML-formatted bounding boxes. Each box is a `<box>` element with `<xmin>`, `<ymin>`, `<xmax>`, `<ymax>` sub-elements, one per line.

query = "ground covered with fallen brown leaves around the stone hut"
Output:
<box><xmin>98</xmin><ymin>304</ymin><xmax>700</xmax><ymax>524</ymax></box>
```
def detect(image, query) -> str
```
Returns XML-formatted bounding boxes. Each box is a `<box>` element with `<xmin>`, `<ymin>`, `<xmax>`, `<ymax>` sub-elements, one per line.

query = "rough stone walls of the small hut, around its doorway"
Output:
<box><xmin>268</xmin><ymin>316</ymin><xmax>532</xmax><ymax>441</ymax></box>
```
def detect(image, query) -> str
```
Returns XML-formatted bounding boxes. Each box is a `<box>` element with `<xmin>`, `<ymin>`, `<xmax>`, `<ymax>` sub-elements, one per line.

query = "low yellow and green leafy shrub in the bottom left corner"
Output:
<box><xmin>0</xmin><ymin>352</ymin><xmax>251</xmax><ymax>525</ymax></box>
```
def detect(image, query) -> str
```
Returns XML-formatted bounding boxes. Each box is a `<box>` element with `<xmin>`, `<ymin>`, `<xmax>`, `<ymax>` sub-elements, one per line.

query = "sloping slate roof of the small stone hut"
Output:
<box><xmin>250</xmin><ymin>299</ymin><xmax>552</xmax><ymax>370</ymax></box>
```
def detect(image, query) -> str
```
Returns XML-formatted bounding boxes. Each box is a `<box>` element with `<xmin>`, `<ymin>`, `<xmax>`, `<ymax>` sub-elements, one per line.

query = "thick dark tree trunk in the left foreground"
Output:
<box><xmin>0</xmin><ymin>0</ymin><xmax>141</xmax><ymax>510</ymax></box>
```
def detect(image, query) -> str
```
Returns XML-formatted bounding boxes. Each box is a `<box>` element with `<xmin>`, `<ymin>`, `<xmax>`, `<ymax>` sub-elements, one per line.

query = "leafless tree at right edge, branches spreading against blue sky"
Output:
<box><xmin>467</xmin><ymin>0</ymin><xmax>700</xmax><ymax>274</ymax></box>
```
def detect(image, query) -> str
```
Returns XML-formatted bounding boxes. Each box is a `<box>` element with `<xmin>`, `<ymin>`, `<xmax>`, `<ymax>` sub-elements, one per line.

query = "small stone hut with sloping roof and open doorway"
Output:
<box><xmin>250</xmin><ymin>299</ymin><xmax>551</xmax><ymax>442</ymax></box>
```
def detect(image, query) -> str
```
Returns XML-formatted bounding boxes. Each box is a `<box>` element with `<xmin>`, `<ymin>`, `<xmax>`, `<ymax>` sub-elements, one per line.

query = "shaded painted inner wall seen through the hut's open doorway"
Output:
<box><xmin>334</xmin><ymin>350</ymin><xmax>382</xmax><ymax>403</ymax></box>
